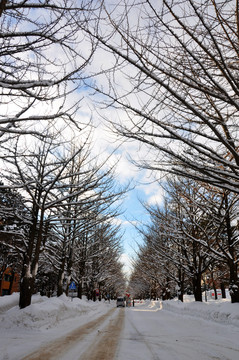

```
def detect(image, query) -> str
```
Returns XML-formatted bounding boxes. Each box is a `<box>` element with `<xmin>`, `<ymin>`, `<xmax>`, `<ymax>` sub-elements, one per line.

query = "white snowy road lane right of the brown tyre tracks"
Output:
<box><xmin>115</xmin><ymin>307</ymin><xmax>239</xmax><ymax>360</ymax></box>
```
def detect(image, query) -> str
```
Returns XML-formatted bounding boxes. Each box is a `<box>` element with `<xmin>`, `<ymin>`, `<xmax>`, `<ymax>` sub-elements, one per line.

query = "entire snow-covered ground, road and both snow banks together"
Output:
<box><xmin>0</xmin><ymin>295</ymin><xmax>239</xmax><ymax>360</ymax></box>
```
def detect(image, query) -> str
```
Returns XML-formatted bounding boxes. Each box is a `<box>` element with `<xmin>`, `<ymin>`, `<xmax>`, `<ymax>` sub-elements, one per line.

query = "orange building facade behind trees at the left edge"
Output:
<box><xmin>0</xmin><ymin>267</ymin><xmax>20</xmax><ymax>296</ymax></box>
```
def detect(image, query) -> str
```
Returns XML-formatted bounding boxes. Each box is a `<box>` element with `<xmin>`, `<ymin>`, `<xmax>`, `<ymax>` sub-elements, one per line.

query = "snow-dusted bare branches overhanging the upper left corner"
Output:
<box><xmin>0</xmin><ymin>0</ymin><xmax>94</xmax><ymax>142</ymax></box>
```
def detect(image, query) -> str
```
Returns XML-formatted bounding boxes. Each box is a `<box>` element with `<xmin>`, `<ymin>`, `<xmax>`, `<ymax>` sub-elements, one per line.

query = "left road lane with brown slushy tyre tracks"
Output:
<box><xmin>22</xmin><ymin>308</ymin><xmax>124</xmax><ymax>360</ymax></box>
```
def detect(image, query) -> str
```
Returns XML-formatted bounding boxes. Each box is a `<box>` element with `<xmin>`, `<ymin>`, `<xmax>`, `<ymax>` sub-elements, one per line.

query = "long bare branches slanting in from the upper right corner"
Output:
<box><xmin>81</xmin><ymin>0</ymin><xmax>239</xmax><ymax>301</ymax></box>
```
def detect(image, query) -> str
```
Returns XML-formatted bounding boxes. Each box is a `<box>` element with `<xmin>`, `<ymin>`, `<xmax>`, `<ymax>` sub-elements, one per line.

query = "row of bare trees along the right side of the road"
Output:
<box><xmin>131</xmin><ymin>178</ymin><xmax>239</xmax><ymax>302</ymax></box>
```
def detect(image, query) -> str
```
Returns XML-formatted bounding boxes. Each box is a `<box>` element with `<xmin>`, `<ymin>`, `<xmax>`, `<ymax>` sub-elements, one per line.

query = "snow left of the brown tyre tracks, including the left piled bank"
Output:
<box><xmin>0</xmin><ymin>294</ymin><xmax>115</xmax><ymax>360</ymax></box>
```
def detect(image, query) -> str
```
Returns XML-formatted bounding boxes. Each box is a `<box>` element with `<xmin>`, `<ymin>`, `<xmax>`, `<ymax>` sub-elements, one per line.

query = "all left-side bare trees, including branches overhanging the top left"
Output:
<box><xmin>0</xmin><ymin>0</ymin><xmax>125</xmax><ymax>308</ymax></box>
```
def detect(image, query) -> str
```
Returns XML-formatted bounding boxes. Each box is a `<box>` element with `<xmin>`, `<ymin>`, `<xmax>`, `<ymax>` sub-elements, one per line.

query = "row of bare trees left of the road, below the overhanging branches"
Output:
<box><xmin>0</xmin><ymin>132</ymin><xmax>126</xmax><ymax>308</ymax></box>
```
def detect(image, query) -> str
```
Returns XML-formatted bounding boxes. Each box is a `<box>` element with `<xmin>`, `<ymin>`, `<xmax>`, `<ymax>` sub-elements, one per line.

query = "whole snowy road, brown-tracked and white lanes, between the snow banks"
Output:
<box><xmin>20</xmin><ymin>305</ymin><xmax>239</xmax><ymax>360</ymax></box>
